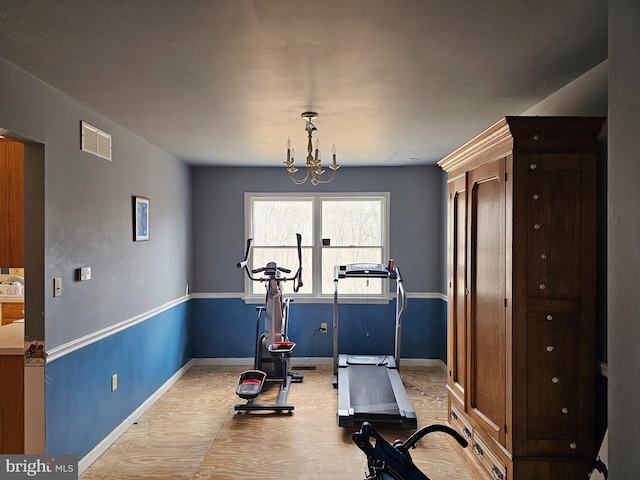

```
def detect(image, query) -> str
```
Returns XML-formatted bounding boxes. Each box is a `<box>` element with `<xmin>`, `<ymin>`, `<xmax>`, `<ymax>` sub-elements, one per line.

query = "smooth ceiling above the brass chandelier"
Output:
<box><xmin>0</xmin><ymin>0</ymin><xmax>607</xmax><ymax>167</ymax></box>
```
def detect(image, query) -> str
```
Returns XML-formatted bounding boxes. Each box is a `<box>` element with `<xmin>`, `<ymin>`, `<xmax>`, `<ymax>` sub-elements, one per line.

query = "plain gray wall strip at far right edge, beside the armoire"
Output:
<box><xmin>607</xmin><ymin>0</ymin><xmax>640</xmax><ymax>474</ymax></box>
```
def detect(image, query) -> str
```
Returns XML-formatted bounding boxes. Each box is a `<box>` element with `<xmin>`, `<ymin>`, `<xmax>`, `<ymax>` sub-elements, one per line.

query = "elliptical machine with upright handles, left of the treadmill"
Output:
<box><xmin>234</xmin><ymin>233</ymin><xmax>304</xmax><ymax>414</ymax></box>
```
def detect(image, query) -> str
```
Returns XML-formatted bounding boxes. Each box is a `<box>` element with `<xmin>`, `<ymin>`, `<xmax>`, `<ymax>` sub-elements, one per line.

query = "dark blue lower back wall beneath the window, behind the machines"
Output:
<box><xmin>191</xmin><ymin>298</ymin><xmax>447</xmax><ymax>362</ymax></box>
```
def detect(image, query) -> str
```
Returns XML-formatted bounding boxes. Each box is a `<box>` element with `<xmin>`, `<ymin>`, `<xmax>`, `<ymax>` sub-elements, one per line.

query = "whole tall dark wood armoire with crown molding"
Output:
<box><xmin>439</xmin><ymin>117</ymin><xmax>604</xmax><ymax>480</ymax></box>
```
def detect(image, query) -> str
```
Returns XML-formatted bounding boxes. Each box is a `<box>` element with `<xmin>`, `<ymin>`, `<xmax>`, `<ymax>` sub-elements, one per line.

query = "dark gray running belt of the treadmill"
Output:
<box><xmin>349</xmin><ymin>365</ymin><xmax>400</xmax><ymax>415</ymax></box>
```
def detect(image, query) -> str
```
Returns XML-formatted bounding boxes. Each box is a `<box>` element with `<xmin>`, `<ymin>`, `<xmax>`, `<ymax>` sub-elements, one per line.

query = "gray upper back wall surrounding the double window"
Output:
<box><xmin>191</xmin><ymin>164</ymin><xmax>446</xmax><ymax>294</ymax></box>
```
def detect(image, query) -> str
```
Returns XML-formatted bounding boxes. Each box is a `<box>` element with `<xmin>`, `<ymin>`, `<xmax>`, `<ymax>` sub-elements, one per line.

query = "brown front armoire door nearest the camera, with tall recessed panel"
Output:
<box><xmin>467</xmin><ymin>158</ymin><xmax>507</xmax><ymax>444</ymax></box>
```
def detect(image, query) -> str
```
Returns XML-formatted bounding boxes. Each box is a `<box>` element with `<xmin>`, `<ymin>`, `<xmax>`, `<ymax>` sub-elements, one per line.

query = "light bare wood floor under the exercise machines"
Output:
<box><xmin>82</xmin><ymin>366</ymin><xmax>477</xmax><ymax>480</ymax></box>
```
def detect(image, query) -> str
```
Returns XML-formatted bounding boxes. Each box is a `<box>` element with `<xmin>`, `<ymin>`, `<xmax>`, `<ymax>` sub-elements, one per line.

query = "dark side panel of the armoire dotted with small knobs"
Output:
<box><xmin>512</xmin><ymin>154</ymin><xmax>596</xmax><ymax>456</ymax></box>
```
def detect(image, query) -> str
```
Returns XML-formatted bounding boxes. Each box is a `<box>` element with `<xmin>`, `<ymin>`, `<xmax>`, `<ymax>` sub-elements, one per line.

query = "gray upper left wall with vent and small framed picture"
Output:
<box><xmin>0</xmin><ymin>59</ymin><xmax>192</xmax><ymax>350</ymax></box>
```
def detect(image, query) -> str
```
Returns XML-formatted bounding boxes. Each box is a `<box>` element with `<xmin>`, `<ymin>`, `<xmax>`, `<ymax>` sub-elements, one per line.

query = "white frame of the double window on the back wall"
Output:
<box><xmin>244</xmin><ymin>192</ymin><xmax>392</xmax><ymax>303</ymax></box>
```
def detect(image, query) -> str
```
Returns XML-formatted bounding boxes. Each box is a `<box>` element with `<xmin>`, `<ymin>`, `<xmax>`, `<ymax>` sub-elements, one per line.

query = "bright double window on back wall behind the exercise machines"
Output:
<box><xmin>245</xmin><ymin>193</ymin><xmax>389</xmax><ymax>297</ymax></box>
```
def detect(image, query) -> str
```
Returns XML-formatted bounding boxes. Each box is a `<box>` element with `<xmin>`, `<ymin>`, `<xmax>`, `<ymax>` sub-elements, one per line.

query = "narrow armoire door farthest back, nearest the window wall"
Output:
<box><xmin>447</xmin><ymin>176</ymin><xmax>467</xmax><ymax>404</ymax></box>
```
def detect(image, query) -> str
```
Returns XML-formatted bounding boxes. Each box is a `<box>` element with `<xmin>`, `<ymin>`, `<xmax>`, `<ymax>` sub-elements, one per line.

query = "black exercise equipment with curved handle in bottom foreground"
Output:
<box><xmin>352</xmin><ymin>422</ymin><xmax>468</xmax><ymax>480</ymax></box>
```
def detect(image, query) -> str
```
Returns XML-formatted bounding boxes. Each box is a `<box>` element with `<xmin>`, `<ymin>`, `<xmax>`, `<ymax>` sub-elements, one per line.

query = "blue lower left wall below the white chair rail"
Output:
<box><xmin>45</xmin><ymin>302</ymin><xmax>191</xmax><ymax>457</ymax></box>
